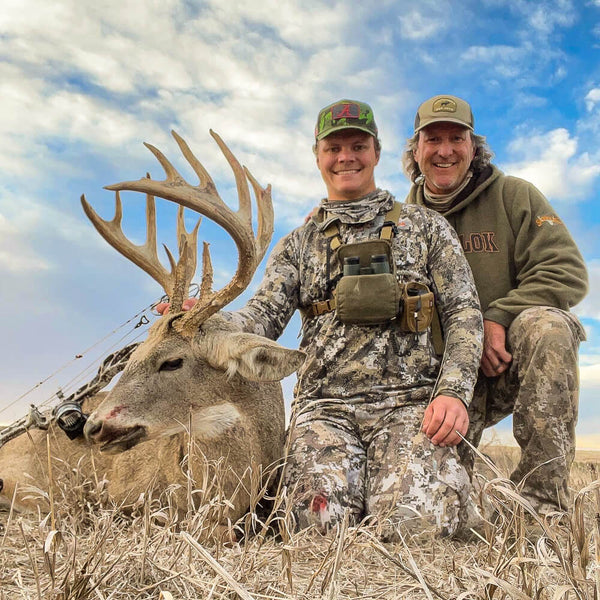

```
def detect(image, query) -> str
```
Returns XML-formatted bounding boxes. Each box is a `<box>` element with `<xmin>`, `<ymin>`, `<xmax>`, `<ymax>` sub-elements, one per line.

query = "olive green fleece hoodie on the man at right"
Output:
<box><xmin>406</xmin><ymin>165</ymin><xmax>587</xmax><ymax>327</ymax></box>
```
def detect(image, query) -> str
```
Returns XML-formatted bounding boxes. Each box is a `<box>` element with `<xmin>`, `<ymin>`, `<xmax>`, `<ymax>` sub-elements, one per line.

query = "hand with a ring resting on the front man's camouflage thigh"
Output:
<box><xmin>422</xmin><ymin>396</ymin><xmax>469</xmax><ymax>448</ymax></box>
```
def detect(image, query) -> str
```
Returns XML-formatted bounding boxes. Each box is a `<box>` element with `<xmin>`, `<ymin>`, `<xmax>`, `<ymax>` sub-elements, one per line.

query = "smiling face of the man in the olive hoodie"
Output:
<box><xmin>414</xmin><ymin>123</ymin><xmax>475</xmax><ymax>194</ymax></box>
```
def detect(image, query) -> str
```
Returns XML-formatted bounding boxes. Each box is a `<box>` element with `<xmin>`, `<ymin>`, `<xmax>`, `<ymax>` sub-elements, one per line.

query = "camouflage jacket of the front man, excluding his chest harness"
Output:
<box><xmin>231</xmin><ymin>190</ymin><xmax>483</xmax><ymax>404</ymax></box>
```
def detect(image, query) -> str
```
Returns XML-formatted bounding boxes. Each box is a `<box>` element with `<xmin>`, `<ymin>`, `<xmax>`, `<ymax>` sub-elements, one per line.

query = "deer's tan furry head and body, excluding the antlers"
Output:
<box><xmin>0</xmin><ymin>315</ymin><xmax>304</xmax><ymax>521</ymax></box>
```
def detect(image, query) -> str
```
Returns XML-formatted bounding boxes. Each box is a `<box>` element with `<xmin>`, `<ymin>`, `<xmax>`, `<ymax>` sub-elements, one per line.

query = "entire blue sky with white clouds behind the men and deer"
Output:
<box><xmin>0</xmin><ymin>0</ymin><xmax>600</xmax><ymax>447</ymax></box>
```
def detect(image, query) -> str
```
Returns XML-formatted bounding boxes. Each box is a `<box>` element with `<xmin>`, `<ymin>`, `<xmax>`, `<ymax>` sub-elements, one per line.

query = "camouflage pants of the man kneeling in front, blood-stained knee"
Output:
<box><xmin>284</xmin><ymin>396</ymin><xmax>478</xmax><ymax>539</ymax></box>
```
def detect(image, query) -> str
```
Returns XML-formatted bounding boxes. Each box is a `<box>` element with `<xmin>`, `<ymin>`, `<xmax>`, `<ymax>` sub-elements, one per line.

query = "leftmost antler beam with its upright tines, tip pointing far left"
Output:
<box><xmin>81</xmin><ymin>191</ymin><xmax>174</xmax><ymax>296</ymax></box>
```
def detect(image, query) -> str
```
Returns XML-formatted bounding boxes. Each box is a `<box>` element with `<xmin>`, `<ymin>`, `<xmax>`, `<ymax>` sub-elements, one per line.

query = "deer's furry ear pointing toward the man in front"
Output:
<box><xmin>219</xmin><ymin>333</ymin><xmax>306</xmax><ymax>381</ymax></box>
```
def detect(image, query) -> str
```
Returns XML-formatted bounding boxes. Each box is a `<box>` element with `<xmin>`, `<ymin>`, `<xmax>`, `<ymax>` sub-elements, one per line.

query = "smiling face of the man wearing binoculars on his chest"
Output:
<box><xmin>317</xmin><ymin>129</ymin><xmax>379</xmax><ymax>202</ymax></box>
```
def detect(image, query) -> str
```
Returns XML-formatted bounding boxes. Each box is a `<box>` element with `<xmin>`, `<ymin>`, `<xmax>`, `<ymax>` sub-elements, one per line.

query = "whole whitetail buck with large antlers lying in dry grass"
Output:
<box><xmin>0</xmin><ymin>131</ymin><xmax>304</xmax><ymax>520</ymax></box>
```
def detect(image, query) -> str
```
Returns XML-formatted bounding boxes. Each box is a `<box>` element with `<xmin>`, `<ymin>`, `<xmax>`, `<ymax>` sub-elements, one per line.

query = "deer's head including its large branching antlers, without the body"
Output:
<box><xmin>81</xmin><ymin>131</ymin><xmax>304</xmax><ymax>451</ymax></box>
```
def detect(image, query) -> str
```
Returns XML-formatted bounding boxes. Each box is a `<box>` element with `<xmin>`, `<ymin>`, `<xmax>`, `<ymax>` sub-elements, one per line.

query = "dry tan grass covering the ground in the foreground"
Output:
<box><xmin>0</xmin><ymin>438</ymin><xmax>600</xmax><ymax>600</ymax></box>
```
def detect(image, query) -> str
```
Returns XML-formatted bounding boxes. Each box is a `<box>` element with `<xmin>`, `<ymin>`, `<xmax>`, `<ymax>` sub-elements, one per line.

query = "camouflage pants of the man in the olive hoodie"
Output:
<box><xmin>459</xmin><ymin>307</ymin><xmax>585</xmax><ymax>513</ymax></box>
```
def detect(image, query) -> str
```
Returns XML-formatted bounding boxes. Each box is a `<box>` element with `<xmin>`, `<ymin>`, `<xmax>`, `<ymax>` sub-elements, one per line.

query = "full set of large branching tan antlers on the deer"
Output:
<box><xmin>81</xmin><ymin>130</ymin><xmax>273</xmax><ymax>330</ymax></box>
